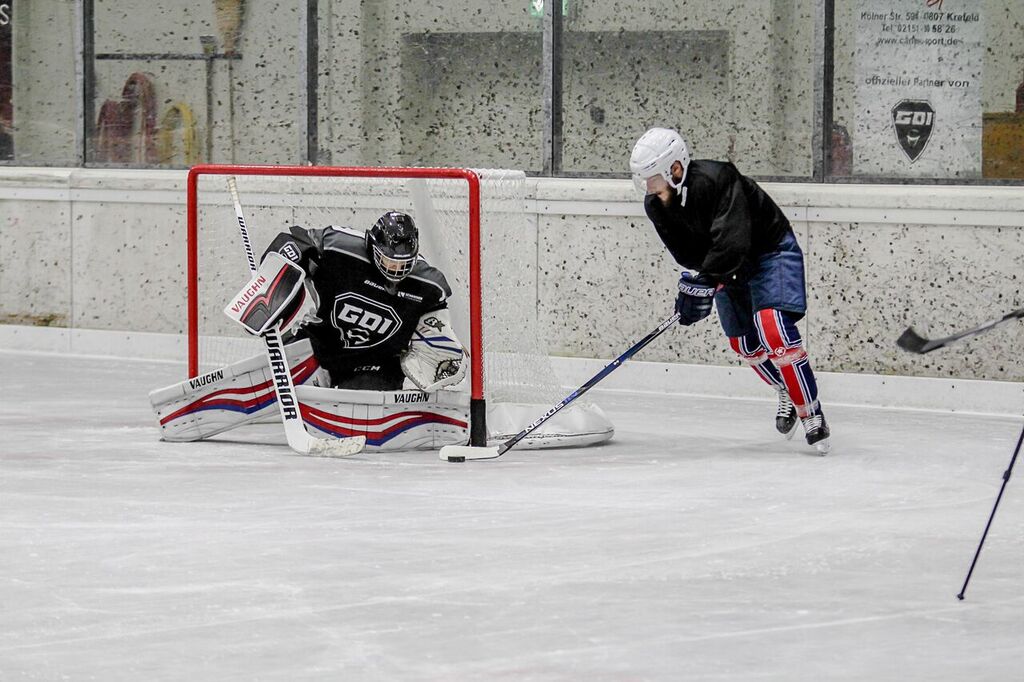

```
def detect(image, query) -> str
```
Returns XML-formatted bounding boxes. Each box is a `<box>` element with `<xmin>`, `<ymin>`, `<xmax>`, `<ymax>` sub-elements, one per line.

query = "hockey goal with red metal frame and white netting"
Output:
<box><xmin>188</xmin><ymin>166</ymin><xmax>611</xmax><ymax>446</ymax></box>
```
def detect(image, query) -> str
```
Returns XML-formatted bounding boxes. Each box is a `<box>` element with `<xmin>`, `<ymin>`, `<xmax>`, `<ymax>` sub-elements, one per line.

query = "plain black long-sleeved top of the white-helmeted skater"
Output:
<box><xmin>644</xmin><ymin>160</ymin><xmax>792</xmax><ymax>285</ymax></box>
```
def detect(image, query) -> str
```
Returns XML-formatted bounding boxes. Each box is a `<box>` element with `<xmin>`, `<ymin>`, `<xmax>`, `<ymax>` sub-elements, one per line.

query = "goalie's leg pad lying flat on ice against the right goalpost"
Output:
<box><xmin>295</xmin><ymin>386</ymin><xmax>469</xmax><ymax>452</ymax></box>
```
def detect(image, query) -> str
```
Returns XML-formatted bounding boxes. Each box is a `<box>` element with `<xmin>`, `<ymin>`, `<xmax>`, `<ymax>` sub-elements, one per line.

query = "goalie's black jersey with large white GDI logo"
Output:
<box><xmin>267</xmin><ymin>225</ymin><xmax>452</xmax><ymax>388</ymax></box>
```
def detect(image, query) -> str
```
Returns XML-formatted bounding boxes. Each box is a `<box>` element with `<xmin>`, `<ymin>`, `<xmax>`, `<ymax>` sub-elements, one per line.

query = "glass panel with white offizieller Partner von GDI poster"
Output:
<box><xmin>831</xmin><ymin>0</ymin><xmax>1024</xmax><ymax>180</ymax></box>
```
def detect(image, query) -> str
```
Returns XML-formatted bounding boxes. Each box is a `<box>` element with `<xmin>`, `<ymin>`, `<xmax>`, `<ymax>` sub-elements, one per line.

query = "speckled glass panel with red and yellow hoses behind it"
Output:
<box><xmin>86</xmin><ymin>0</ymin><xmax>306</xmax><ymax>167</ymax></box>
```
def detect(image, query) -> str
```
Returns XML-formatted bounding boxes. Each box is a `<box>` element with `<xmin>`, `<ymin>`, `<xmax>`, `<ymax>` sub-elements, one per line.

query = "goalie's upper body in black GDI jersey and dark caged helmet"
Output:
<box><xmin>264</xmin><ymin>211</ymin><xmax>466</xmax><ymax>391</ymax></box>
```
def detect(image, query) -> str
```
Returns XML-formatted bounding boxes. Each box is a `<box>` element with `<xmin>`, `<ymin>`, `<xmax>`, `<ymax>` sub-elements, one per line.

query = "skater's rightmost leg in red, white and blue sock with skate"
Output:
<box><xmin>754</xmin><ymin>308</ymin><xmax>829</xmax><ymax>453</ymax></box>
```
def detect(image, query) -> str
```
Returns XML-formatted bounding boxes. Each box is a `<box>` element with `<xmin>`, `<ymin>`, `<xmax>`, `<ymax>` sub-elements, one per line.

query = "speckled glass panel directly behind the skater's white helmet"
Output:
<box><xmin>562</xmin><ymin>0</ymin><xmax>817</xmax><ymax>177</ymax></box>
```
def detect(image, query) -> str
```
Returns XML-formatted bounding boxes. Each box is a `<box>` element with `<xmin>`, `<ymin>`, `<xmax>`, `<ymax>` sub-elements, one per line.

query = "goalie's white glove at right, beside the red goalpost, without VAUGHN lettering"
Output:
<box><xmin>401</xmin><ymin>308</ymin><xmax>466</xmax><ymax>392</ymax></box>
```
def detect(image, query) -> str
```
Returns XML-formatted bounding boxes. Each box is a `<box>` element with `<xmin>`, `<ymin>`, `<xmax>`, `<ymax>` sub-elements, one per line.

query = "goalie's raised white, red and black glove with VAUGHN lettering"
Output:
<box><xmin>224</xmin><ymin>252</ymin><xmax>306</xmax><ymax>336</ymax></box>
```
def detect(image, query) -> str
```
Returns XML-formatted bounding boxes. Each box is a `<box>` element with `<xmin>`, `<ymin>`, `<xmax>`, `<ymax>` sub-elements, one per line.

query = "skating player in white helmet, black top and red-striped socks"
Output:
<box><xmin>630</xmin><ymin>128</ymin><xmax>829</xmax><ymax>454</ymax></box>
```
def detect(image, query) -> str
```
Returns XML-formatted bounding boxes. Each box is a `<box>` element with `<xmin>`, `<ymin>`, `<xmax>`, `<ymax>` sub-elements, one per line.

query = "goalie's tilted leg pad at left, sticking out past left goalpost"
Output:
<box><xmin>150</xmin><ymin>340</ymin><xmax>319</xmax><ymax>441</ymax></box>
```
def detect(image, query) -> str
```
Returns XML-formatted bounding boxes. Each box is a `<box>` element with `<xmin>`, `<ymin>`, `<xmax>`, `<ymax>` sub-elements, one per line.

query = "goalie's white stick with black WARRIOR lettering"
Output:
<box><xmin>227</xmin><ymin>177</ymin><xmax>367</xmax><ymax>457</ymax></box>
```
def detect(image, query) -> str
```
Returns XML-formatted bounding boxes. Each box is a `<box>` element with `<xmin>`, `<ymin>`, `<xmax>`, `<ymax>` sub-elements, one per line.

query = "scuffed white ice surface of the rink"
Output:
<box><xmin>0</xmin><ymin>352</ymin><xmax>1024</xmax><ymax>682</ymax></box>
